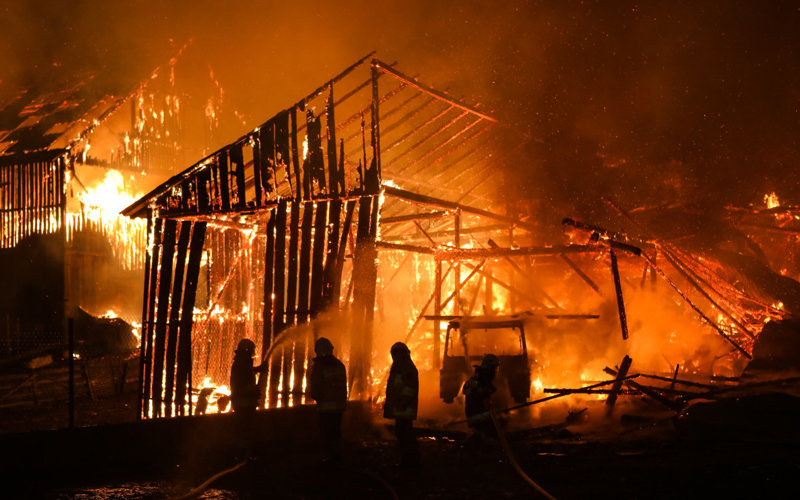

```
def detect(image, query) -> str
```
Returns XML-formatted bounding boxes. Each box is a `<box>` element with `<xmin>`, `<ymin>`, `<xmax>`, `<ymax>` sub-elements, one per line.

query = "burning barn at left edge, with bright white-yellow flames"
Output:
<box><xmin>0</xmin><ymin>44</ymin><xmax>242</xmax><ymax>356</ymax></box>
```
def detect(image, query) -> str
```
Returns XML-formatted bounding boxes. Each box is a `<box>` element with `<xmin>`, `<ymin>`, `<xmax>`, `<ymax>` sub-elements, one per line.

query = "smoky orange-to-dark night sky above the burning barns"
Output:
<box><xmin>0</xmin><ymin>0</ymin><xmax>800</xmax><ymax>217</ymax></box>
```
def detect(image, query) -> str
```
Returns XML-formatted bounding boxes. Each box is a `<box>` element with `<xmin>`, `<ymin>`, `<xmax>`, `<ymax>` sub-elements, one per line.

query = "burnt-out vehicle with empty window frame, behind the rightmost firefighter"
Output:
<box><xmin>439</xmin><ymin>316</ymin><xmax>531</xmax><ymax>403</ymax></box>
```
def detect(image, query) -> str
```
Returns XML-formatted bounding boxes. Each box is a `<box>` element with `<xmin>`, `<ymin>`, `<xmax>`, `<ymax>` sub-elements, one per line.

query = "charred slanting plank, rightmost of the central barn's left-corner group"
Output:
<box><xmin>175</xmin><ymin>222</ymin><xmax>206</xmax><ymax>415</ymax></box>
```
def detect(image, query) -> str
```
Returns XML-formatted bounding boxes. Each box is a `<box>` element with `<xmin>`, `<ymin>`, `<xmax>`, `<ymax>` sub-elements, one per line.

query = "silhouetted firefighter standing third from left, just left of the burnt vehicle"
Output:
<box><xmin>383</xmin><ymin>342</ymin><xmax>420</xmax><ymax>468</ymax></box>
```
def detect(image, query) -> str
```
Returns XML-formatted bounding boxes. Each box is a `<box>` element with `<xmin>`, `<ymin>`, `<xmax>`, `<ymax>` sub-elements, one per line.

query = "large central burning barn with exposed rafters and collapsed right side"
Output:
<box><xmin>123</xmin><ymin>54</ymin><xmax>791</xmax><ymax>424</ymax></box>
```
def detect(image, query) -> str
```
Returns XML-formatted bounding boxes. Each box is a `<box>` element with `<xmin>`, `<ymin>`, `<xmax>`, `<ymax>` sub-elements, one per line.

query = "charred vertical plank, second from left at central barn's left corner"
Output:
<box><xmin>153</xmin><ymin>219</ymin><xmax>177</xmax><ymax>417</ymax></box>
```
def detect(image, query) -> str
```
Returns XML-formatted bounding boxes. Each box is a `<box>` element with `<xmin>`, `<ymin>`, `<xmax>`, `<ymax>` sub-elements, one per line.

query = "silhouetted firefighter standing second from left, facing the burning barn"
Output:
<box><xmin>308</xmin><ymin>337</ymin><xmax>347</xmax><ymax>462</ymax></box>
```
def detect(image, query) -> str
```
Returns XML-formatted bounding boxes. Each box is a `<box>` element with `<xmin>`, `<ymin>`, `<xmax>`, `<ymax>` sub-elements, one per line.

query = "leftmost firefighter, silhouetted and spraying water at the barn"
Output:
<box><xmin>230</xmin><ymin>339</ymin><xmax>263</xmax><ymax>447</ymax></box>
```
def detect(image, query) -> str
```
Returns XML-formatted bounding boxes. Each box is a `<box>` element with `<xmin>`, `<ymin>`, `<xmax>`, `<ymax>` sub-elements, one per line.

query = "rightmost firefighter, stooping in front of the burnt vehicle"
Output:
<box><xmin>462</xmin><ymin>354</ymin><xmax>500</xmax><ymax>456</ymax></box>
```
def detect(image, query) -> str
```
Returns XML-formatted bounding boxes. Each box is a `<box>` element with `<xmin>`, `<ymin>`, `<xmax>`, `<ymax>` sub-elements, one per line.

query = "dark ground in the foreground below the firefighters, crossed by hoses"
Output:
<box><xmin>10</xmin><ymin>418</ymin><xmax>800</xmax><ymax>500</ymax></box>
